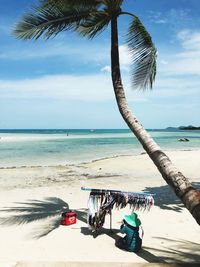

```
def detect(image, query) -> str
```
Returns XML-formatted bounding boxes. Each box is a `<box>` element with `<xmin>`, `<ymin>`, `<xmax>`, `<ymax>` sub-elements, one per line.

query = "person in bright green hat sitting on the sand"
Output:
<box><xmin>115</xmin><ymin>212</ymin><xmax>143</xmax><ymax>252</ymax></box>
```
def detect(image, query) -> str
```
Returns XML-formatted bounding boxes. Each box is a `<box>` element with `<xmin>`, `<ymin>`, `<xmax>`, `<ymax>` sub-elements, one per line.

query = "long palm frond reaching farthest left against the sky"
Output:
<box><xmin>13</xmin><ymin>0</ymin><xmax>97</xmax><ymax>39</ymax></box>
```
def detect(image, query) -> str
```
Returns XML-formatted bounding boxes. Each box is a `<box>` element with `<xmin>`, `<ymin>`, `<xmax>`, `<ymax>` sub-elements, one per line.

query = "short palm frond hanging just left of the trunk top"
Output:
<box><xmin>77</xmin><ymin>11</ymin><xmax>110</xmax><ymax>39</ymax></box>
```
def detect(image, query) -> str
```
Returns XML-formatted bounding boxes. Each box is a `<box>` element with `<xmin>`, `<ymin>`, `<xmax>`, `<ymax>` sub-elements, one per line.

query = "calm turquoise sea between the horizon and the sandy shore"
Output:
<box><xmin>0</xmin><ymin>129</ymin><xmax>200</xmax><ymax>168</ymax></box>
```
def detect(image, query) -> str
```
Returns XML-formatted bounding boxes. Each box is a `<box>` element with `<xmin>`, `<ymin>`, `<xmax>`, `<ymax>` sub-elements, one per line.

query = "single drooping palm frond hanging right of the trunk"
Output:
<box><xmin>127</xmin><ymin>17</ymin><xmax>157</xmax><ymax>90</ymax></box>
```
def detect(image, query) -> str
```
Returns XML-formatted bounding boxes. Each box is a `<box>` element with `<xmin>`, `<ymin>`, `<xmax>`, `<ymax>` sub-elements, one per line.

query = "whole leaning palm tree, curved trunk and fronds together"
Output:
<box><xmin>14</xmin><ymin>0</ymin><xmax>200</xmax><ymax>224</ymax></box>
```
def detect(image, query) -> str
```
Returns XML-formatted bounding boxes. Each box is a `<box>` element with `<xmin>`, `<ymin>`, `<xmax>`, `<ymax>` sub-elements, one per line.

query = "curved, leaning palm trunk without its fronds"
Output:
<box><xmin>111</xmin><ymin>16</ymin><xmax>200</xmax><ymax>225</ymax></box>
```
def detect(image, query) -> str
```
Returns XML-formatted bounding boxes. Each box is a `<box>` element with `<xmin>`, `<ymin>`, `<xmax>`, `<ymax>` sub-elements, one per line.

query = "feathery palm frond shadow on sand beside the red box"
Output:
<box><xmin>0</xmin><ymin>197</ymin><xmax>87</xmax><ymax>239</ymax></box>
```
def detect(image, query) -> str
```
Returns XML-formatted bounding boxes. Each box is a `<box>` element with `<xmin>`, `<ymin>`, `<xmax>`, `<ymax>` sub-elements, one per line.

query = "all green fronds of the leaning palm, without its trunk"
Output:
<box><xmin>14</xmin><ymin>0</ymin><xmax>156</xmax><ymax>89</ymax></box>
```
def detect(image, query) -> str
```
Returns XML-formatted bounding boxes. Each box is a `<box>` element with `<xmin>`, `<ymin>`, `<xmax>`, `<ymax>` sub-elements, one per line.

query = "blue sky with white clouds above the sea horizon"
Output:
<box><xmin>0</xmin><ymin>0</ymin><xmax>200</xmax><ymax>129</ymax></box>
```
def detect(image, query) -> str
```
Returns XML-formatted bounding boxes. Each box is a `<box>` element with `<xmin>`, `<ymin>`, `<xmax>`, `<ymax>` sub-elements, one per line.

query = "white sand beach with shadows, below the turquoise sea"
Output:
<box><xmin>0</xmin><ymin>151</ymin><xmax>200</xmax><ymax>267</ymax></box>
